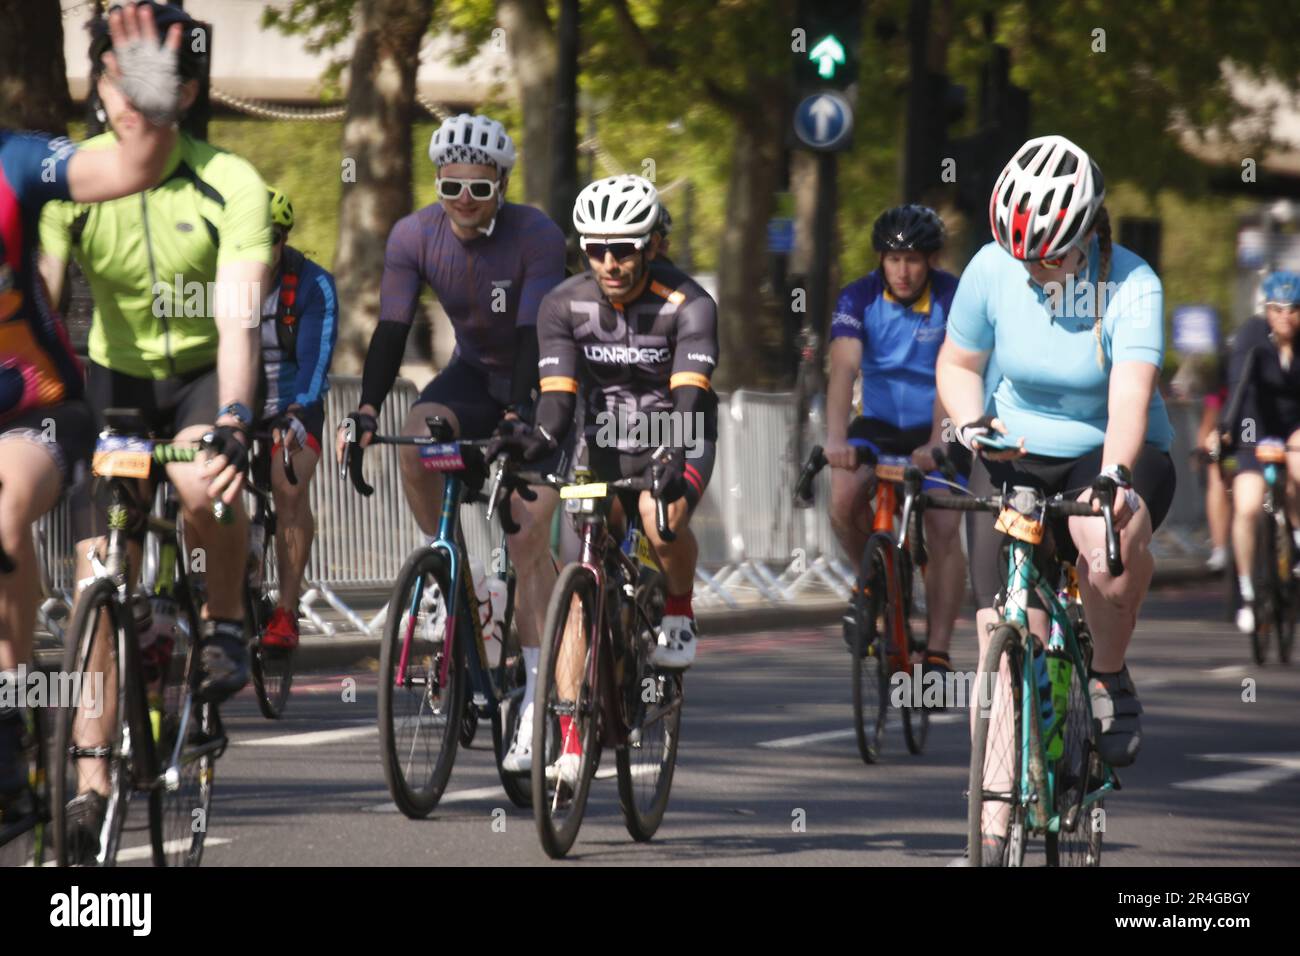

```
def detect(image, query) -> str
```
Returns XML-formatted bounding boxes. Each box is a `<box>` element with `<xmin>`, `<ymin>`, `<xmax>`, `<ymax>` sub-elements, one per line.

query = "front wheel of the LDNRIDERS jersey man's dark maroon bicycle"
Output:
<box><xmin>532</xmin><ymin>563</ymin><xmax>603</xmax><ymax>860</ymax></box>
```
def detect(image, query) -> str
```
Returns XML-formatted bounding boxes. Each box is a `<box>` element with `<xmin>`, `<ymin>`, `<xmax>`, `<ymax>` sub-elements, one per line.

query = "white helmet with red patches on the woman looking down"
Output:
<box><xmin>988</xmin><ymin>137</ymin><xmax>1106</xmax><ymax>260</ymax></box>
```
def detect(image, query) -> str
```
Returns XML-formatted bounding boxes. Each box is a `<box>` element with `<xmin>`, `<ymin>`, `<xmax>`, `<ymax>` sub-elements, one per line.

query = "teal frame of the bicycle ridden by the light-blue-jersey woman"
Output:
<box><xmin>1002</xmin><ymin>538</ymin><xmax>1115</xmax><ymax>834</ymax></box>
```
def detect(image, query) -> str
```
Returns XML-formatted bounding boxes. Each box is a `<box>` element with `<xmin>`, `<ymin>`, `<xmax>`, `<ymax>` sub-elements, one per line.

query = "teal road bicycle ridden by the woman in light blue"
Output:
<box><xmin>910</xmin><ymin>472</ymin><xmax>1123</xmax><ymax>866</ymax></box>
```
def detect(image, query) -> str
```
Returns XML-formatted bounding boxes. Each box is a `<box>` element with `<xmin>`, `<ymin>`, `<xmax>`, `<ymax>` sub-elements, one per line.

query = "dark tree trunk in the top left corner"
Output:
<box><xmin>0</xmin><ymin>0</ymin><xmax>73</xmax><ymax>135</ymax></box>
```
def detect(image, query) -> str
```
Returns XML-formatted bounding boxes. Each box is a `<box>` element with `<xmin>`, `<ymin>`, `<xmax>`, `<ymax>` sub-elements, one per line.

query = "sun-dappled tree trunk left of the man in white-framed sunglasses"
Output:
<box><xmin>334</xmin><ymin>0</ymin><xmax>433</xmax><ymax>375</ymax></box>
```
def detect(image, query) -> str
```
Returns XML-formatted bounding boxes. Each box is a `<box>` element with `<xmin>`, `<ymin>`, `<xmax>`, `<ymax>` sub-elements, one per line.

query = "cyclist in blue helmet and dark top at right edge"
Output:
<box><xmin>1219</xmin><ymin>272</ymin><xmax>1300</xmax><ymax>633</ymax></box>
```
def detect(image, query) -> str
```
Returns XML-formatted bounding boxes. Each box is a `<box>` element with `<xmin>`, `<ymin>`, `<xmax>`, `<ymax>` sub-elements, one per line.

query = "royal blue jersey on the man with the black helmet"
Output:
<box><xmin>831</xmin><ymin>269</ymin><xmax>957</xmax><ymax>429</ymax></box>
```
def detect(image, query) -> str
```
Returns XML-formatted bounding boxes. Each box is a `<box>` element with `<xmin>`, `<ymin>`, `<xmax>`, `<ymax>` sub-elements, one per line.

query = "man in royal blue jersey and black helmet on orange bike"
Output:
<box><xmin>824</xmin><ymin>204</ymin><xmax>970</xmax><ymax>697</ymax></box>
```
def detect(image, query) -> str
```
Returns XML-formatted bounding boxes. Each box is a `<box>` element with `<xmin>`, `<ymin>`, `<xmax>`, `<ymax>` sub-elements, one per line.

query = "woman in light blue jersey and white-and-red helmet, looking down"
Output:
<box><xmin>937</xmin><ymin>135</ymin><xmax>1175</xmax><ymax>858</ymax></box>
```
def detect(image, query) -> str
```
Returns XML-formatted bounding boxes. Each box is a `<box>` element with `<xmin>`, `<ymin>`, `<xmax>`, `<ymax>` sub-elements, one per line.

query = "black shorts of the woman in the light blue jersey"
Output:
<box><xmin>966</xmin><ymin>445</ymin><xmax>1177</xmax><ymax>607</ymax></box>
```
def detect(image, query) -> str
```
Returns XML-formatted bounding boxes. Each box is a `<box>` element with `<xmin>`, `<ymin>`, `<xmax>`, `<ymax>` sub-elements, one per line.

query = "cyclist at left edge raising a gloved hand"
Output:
<box><xmin>0</xmin><ymin>8</ymin><xmax>181</xmax><ymax>825</ymax></box>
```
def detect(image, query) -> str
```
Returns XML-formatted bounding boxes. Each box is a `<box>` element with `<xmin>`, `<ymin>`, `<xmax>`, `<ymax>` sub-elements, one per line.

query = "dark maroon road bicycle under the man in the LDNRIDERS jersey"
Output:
<box><xmin>520</xmin><ymin>466</ymin><xmax>683</xmax><ymax>858</ymax></box>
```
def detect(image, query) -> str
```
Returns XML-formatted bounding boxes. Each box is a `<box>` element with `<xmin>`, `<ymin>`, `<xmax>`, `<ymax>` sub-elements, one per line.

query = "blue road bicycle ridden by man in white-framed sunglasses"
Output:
<box><xmin>341</xmin><ymin>418</ymin><xmax>530</xmax><ymax>819</ymax></box>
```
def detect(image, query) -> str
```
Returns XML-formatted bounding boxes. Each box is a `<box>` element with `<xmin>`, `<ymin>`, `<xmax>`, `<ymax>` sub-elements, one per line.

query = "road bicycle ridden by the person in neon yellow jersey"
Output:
<box><xmin>51</xmin><ymin>408</ymin><xmax>233</xmax><ymax>866</ymax></box>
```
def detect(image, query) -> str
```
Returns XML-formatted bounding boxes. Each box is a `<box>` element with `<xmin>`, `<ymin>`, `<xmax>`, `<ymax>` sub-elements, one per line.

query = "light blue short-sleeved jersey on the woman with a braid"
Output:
<box><xmin>948</xmin><ymin>239</ymin><xmax>1174</xmax><ymax>458</ymax></box>
